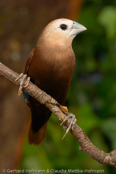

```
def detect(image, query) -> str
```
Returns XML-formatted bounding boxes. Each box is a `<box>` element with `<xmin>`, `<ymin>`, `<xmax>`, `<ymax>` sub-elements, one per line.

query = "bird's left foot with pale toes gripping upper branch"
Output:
<box><xmin>15</xmin><ymin>73</ymin><xmax>30</xmax><ymax>95</ymax></box>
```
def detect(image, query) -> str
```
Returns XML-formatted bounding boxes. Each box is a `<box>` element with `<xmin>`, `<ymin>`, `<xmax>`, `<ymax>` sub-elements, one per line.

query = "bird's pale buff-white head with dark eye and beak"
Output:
<box><xmin>38</xmin><ymin>18</ymin><xmax>87</xmax><ymax>45</ymax></box>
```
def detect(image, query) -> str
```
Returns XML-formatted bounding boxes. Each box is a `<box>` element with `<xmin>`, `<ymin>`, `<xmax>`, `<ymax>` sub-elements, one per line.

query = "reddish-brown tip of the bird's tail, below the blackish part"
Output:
<box><xmin>28</xmin><ymin>122</ymin><xmax>47</xmax><ymax>145</ymax></box>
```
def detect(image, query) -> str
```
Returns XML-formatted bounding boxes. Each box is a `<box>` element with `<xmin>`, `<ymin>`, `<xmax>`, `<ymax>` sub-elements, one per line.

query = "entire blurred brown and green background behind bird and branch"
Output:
<box><xmin>0</xmin><ymin>0</ymin><xmax>116</xmax><ymax>174</ymax></box>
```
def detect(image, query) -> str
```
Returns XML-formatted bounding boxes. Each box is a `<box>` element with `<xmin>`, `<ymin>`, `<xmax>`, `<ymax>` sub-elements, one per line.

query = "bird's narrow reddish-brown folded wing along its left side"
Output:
<box><xmin>24</xmin><ymin>48</ymin><xmax>35</xmax><ymax>75</ymax></box>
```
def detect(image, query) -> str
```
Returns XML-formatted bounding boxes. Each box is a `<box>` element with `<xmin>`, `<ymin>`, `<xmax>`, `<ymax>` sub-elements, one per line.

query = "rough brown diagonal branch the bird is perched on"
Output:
<box><xmin>0</xmin><ymin>62</ymin><xmax>116</xmax><ymax>167</ymax></box>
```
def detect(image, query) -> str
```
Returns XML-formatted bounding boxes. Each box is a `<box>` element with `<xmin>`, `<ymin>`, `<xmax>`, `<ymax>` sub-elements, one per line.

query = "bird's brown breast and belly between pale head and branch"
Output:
<box><xmin>28</xmin><ymin>47</ymin><xmax>75</xmax><ymax>104</ymax></box>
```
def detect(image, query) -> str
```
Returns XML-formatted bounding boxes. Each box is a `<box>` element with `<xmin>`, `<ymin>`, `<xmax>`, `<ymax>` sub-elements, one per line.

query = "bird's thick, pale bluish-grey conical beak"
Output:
<box><xmin>69</xmin><ymin>21</ymin><xmax>87</xmax><ymax>36</ymax></box>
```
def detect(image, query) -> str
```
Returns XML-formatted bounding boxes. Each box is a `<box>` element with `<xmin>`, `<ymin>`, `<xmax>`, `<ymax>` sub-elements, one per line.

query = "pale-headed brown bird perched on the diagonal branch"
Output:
<box><xmin>16</xmin><ymin>18</ymin><xmax>86</xmax><ymax>145</ymax></box>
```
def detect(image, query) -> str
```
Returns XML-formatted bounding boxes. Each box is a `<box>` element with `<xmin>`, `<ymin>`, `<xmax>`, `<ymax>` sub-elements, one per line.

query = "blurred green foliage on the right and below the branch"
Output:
<box><xmin>19</xmin><ymin>0</ymin><xmax>116</xmax><ymax>174</ymax></box>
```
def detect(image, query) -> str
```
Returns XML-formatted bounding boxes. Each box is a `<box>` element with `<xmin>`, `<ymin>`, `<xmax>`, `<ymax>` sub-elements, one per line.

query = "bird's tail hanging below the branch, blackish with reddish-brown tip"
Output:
<box><xmin>28</xmin><ymin>104</ymin><xmax>51</xmax><ymax>145</ymax></box>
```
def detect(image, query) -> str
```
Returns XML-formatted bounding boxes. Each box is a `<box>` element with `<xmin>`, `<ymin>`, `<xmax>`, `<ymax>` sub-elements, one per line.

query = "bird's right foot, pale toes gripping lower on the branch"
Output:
<box><xmin>60</xmin><ymin>113</ymin><xmax>77</xmax><ymax>140</ymax></box>
